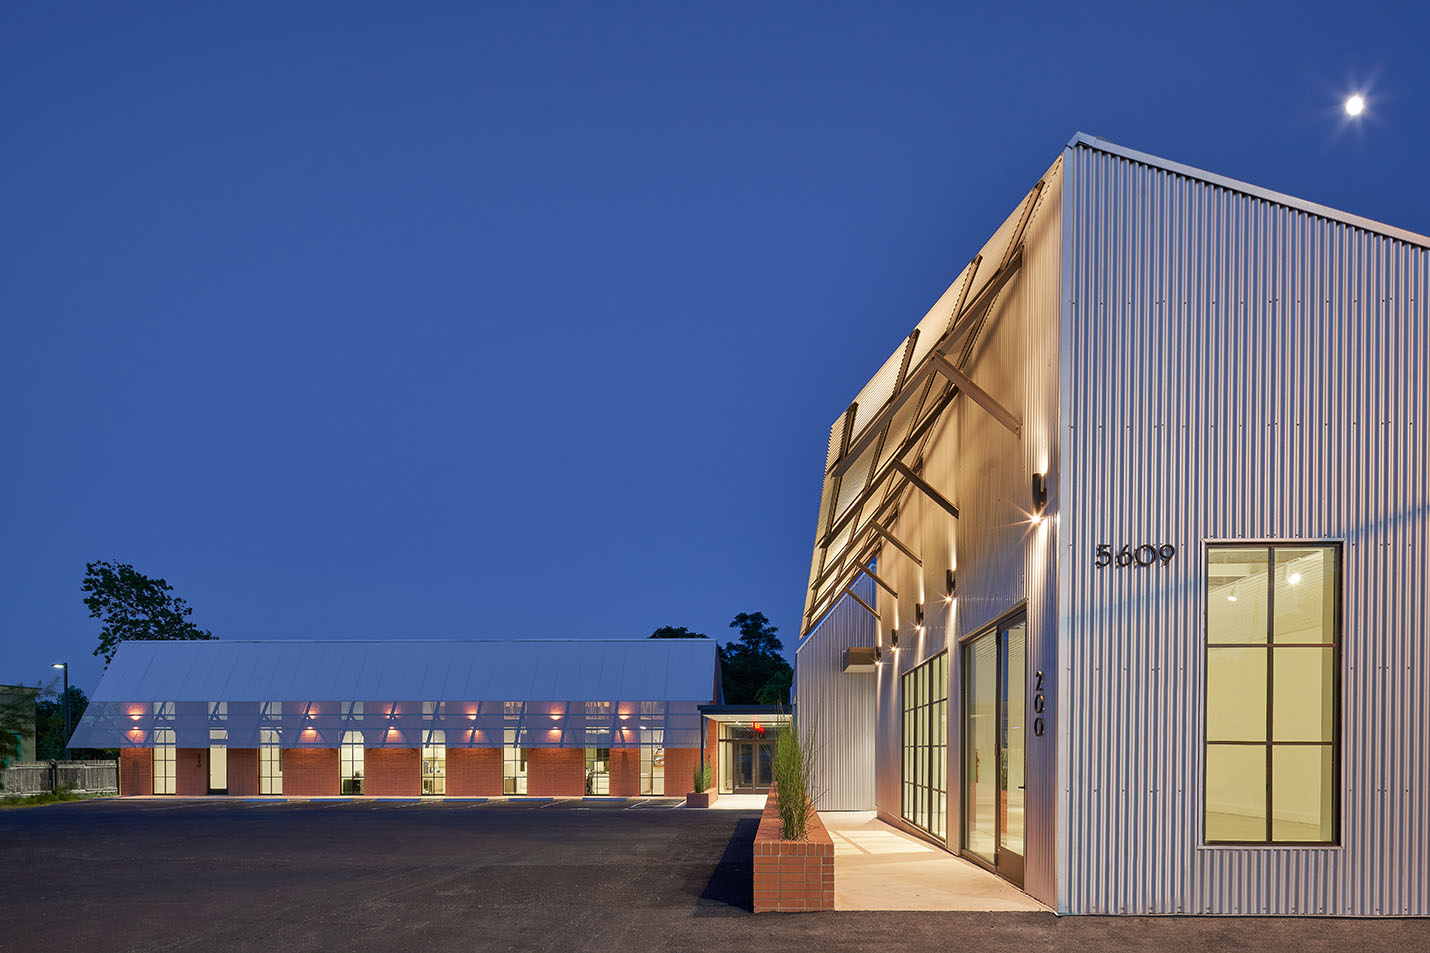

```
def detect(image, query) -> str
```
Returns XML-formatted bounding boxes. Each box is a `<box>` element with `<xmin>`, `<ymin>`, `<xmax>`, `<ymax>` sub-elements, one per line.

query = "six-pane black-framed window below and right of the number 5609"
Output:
<box><xmin>1205</xmin><ymin>544</ymin><xmax>1340</xmax><ymax>844</ymax></box>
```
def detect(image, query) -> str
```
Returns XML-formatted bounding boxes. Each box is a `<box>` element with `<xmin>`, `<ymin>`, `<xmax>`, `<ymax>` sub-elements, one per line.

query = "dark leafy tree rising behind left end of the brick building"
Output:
<box><xmin>83</xmin><ymin>561</ymin><xmax>213</xmax><ymax>665</ymax></box>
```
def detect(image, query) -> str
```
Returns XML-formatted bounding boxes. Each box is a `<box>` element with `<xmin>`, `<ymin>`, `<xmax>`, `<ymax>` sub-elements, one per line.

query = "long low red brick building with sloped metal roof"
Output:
<box><xmin>73</xmin><ymin>640</ymin><xmax>776</xmax><ymax>797</ymax></box>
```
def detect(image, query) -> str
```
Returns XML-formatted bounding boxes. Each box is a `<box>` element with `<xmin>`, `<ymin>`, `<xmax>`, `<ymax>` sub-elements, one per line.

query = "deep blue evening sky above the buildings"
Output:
<box><xmin>0</xmin><ymin>3</ymin><xmax>1430</xmax><ymax>690</ymax></box>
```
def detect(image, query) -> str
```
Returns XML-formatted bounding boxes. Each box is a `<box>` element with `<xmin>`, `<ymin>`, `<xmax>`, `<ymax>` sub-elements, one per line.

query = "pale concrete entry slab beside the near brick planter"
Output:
<box><xmin>819</xmin><ymin>811</ymin><xmax>1048</xmax><ymax>913</ymax></box>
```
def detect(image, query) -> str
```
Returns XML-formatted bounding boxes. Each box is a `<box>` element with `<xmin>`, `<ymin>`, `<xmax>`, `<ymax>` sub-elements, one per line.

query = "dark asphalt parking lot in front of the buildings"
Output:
<box><xmin>0</xmin><ymin>800</ymin><xmax>1430</xmax><ymax>953</ymax></box>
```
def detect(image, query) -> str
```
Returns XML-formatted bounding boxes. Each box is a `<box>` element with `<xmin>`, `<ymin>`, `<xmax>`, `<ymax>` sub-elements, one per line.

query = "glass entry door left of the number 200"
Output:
<box><xmin>962</xmin><ymin>612</ymin><xmax>1028</xmax><ymax>887</ymax></box>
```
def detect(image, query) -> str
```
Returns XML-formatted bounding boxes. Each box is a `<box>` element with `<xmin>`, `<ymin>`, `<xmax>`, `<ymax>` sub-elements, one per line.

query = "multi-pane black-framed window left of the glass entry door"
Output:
<box><xmin>902</xmin><ymin>653</ymin><xmax>948</xmax><ymax>839</ymax></box>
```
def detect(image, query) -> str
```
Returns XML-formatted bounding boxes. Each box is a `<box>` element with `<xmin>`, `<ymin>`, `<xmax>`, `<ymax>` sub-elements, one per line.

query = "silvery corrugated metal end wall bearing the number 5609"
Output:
<box><xmin>1058</xmin><ymin>140</ymin><xmax>1430</xmax><ymax>916</ymax></box>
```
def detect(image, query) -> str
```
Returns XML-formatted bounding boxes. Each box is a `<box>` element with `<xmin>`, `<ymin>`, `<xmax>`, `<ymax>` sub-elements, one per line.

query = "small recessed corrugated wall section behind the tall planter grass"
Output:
<box><xmin>795</xmin><ymin>566</ymin><xmax>878</xmax><ymax>811</ymax></box>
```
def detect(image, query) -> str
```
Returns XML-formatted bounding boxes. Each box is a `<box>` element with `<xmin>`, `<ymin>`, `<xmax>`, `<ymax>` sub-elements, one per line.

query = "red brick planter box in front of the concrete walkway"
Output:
<box><xmin>755</xmin><ymin>790</ymin><xmax>834</xmax><ymax>913</ymax></box>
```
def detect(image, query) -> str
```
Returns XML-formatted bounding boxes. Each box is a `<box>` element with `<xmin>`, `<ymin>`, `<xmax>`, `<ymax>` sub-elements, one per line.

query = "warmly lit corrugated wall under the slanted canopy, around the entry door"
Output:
<box><xmin>875</xmin><ymin>160</ymin><xmax>1062</xmax><ymax>904</ymax></box>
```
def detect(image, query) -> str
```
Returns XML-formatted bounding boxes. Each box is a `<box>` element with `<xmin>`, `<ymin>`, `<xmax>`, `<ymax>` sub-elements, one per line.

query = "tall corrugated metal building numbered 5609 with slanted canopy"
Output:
<box><xmin>797</xmin><ymin>135</ymin><xmax>1430</xmax><ymax>916</ymax></box>
